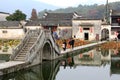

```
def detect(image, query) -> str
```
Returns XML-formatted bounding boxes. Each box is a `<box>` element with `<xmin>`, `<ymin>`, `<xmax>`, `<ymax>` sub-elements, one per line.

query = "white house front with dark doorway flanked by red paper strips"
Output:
<box><xmin>73</xmin><ymin>18</ymin><xmax>102</xmax><ymax>41</ymax></box>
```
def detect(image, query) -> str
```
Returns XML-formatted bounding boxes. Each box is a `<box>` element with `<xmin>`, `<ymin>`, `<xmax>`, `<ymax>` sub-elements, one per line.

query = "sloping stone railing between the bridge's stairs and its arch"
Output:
<box><xmin>25</xmin><ymin>30</ymin><xmax>45</xmax><ymax>63</ymax></box>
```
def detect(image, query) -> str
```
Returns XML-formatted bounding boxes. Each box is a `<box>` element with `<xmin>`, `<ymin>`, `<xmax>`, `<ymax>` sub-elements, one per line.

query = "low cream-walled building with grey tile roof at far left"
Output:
<box><xmin>0</xmin><ymin>21</ymin><xmax>24</xmax><ymax>39</ymax></box>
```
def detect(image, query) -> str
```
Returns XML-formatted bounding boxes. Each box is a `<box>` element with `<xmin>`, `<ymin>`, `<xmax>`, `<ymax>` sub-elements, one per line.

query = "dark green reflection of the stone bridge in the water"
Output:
<box><xmin>0</xmin><ymin>61</ymin><xmax>60</xmax><ymax>80</ymax></box>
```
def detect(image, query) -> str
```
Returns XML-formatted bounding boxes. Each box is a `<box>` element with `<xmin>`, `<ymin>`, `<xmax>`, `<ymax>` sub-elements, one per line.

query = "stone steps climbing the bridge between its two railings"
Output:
<box><xmin>14</xmin><ymin>33</ymin><xmax>38</xmax><ymax>61</ymax></box>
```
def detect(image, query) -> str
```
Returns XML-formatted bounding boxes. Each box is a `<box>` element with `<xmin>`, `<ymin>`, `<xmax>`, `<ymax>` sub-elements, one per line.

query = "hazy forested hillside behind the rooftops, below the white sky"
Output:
<box><xmin>38</xmin><ymin>1</ymin><xmax>120</xmax><ymax>19</ymax></box>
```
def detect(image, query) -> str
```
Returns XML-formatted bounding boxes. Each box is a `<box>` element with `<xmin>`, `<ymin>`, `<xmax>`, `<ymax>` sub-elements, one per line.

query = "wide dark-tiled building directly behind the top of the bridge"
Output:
<box><xmin>25</xmin><ymin>12</ymin><xmax>77</xmax><ymax>39</ymax></box>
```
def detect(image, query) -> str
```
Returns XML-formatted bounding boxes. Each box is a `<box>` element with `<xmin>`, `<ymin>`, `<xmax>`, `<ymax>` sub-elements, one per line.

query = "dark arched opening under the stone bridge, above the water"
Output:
<box><xmin>42</xmin><ymin>39</ymin><xmax>53</xmax><ymax>60</ymax></box>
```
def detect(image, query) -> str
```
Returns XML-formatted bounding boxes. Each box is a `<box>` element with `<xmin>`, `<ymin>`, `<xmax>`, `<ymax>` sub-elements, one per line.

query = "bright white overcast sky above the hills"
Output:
<box><xmin>35</xmin><ymin>0</ymin><xmax>120</xmax><ymax>8</ymax></box>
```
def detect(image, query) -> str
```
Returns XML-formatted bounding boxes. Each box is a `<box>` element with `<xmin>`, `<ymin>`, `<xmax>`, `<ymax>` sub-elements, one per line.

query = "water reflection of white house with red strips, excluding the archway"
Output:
<box><xmin>74</xmin><ymin>50</ymin><xmax>102</xmax><ymax>66</ymax></box>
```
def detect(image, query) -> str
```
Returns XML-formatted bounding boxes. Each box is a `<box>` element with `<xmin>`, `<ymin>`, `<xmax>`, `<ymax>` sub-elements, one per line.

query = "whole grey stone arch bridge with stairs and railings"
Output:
<box><xmin>10</xmin><ymin>29</ymin><xmax>60</xmax><ymax>65</ymax></box>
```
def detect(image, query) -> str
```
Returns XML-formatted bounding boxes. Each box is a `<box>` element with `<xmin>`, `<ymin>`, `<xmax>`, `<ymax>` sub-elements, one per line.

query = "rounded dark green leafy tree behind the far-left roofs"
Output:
<box><xmin>6</xmin><ymin>10</ymin><xmax>26</xmax><ymax>21</ymax></box>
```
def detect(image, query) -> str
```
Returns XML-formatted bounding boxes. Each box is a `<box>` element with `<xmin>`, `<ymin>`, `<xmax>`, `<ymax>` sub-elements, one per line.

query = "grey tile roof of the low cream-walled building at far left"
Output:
<box><xmin>0</xmin><ymin>21</ymin><xmax>20</xmax><ymax>28</ymax></box>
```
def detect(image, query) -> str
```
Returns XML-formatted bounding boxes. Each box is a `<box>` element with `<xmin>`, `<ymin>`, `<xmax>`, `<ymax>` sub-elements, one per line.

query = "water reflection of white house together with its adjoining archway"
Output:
<box><xmin>74</xmin><ymin>49</ymin><xmax>111</xmax><ymax>66</ymax></box>
